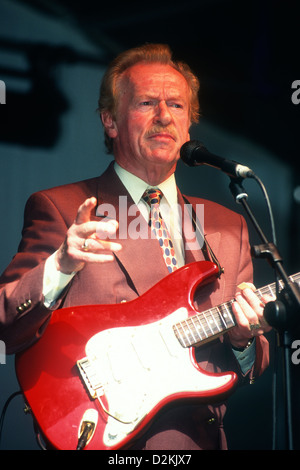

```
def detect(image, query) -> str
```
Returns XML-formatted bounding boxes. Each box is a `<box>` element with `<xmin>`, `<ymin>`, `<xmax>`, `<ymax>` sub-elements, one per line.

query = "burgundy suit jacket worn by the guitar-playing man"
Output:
<box><xmin>0</xmin><ymin>164</ymin><xmax>268</xmax><ymax>450</ymax></box>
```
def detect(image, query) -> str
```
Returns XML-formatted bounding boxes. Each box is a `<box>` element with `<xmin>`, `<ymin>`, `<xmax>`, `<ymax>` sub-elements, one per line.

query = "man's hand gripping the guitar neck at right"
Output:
<box><xmin>228</xmin><ymin>283</ymin><xmax>274</xmax><ymax>348</ymax></box>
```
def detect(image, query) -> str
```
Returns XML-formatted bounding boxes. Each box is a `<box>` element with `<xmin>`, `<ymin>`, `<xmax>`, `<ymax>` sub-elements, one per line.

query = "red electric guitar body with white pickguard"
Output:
<box><xmin>16</xmin><ymin>261</ymin><xmax>237</xmax><ymax>450</ymax></box>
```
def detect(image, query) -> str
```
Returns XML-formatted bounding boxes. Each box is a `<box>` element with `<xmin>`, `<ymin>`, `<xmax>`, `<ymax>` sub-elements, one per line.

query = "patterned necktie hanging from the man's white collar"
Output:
<box><xmin>143</xmin><ymin>189</ymin><xmax>178</xmax><ymax>273</ymax></box>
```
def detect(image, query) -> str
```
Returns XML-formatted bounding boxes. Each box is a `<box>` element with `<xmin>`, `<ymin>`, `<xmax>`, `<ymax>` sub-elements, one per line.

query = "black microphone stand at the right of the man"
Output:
<box><xmin>229</xmin><ymin>175</ymin><xmax>300</xmax><ymax>450</ymax></box>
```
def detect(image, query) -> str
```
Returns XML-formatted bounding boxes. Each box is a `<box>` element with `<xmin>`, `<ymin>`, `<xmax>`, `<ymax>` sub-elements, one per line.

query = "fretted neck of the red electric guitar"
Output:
<box><xmin>173</xmin><ymin>273</ymin><xmax>300</xmax><ymax>348</ymax></box>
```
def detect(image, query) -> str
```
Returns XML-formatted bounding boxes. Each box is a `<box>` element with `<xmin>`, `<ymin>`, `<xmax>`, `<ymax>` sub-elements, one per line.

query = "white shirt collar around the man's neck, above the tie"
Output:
<box><xmin>114</xmin><ymin>162</ymin><xmax>177</xmax><ymax>206</ymax></box>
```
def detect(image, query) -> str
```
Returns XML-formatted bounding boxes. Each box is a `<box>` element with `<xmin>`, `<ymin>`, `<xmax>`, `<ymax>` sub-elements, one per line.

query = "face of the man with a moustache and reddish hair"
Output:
<box><xmin>103</xmin><ymin>63</ymin><xmax>190</xmax><ymax>184</ymax></box>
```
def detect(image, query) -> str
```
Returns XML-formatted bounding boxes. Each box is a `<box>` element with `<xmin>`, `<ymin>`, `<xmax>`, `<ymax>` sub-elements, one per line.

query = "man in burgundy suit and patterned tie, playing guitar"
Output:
<box><xmin>0</xmin><ymin>45</ymin><xmax>269</xmax><ymax>450</ymax></box>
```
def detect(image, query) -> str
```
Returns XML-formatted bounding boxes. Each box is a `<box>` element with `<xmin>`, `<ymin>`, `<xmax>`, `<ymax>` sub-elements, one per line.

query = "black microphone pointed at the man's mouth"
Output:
<box><xmin>180</xmin><ymin>140</ymin><xmax>254</xmax><ymax>178</ymax></box>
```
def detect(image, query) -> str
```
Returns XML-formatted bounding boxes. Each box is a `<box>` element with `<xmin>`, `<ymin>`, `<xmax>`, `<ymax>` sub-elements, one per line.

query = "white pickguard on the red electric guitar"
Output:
<box><xmin>86</xmin><ymin>308</ymin><xmax>231</xmax><ymax>446</ymax></box>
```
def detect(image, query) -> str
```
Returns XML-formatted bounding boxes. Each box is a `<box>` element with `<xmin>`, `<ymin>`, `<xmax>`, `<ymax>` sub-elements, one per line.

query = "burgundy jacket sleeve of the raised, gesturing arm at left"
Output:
<box><xmin>0</xmin><ymin>193</ymin><xmax>67</xmax><ymax>354</ymax></box>
